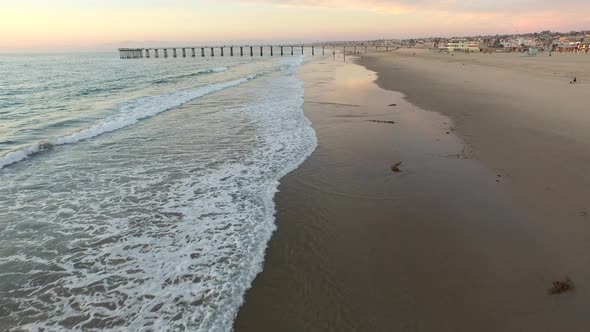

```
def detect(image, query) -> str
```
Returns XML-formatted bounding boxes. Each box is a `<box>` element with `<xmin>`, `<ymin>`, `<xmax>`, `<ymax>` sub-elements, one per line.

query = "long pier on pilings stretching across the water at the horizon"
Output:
<box><xmin>119</xmin><ymin>42</ymin><xmax>399</xmax><ymax>59</ymax></box>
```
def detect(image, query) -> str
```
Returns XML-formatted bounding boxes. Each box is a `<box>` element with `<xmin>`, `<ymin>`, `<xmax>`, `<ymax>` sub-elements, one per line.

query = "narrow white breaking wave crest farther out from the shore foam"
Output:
<box><xmin>0</xmin><ymin>76</ymin><xmax>257</xmax><ymax>169</ymax></box>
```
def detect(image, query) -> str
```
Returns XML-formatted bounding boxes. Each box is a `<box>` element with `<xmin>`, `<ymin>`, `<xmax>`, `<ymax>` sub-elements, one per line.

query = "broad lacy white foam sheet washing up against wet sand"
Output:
<box><xmin>0</xmin><ymin>55</ymin><xmax>317</xmax><ymax>332</ymax></box>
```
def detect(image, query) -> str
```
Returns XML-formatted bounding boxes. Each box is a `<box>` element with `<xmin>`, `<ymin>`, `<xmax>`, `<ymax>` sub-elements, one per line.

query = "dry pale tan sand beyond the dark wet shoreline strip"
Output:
<box><xmin>361</xmin><ymin>49</ymin><xmax>590</xmax><ymax>300</ymax></box>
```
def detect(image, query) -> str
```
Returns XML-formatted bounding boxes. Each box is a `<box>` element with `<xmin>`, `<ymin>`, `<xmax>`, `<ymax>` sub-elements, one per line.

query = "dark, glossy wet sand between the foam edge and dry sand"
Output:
<box><xmin>235</xmin><ymin>55</ymin><xmax>590</xmax><ymax>331</ymax></box>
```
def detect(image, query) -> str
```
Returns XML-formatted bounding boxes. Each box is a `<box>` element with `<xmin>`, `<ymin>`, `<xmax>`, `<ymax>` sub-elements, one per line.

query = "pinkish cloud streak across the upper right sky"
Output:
<box><xmin>218</xmin><ymin>0</ymin><xmax>590</xmax><ymax>35</ymax></box>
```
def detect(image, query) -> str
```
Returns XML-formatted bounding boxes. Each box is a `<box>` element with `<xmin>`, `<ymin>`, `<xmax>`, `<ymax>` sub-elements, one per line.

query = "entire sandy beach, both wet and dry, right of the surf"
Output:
<box><xmin>234</xmin><ymin>50</ymin><xmax>590</xmax><ymax>331</ymax></box>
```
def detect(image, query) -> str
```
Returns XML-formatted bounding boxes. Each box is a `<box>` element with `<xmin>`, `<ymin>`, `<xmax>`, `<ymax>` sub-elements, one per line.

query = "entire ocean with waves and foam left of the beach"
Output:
<box><xmin>0</xmin><ymin>52</ymin><xmax>317</xmax><ymax>331</ymax></box>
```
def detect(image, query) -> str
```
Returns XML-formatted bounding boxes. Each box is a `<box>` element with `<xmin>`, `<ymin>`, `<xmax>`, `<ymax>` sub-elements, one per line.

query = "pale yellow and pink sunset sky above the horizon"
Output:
<box><xmin>0</xmin><ymin>0</ymin><xmax>590</xmax><ymax>52</ymax></box>
